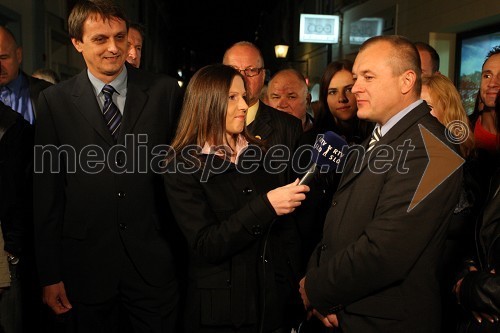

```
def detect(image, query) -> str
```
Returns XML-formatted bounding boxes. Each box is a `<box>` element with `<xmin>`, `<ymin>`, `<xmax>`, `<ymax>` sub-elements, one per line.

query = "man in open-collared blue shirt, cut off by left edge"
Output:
<box><xmin>0</xmin><ymin>26</ymin><xmax>50</xmax><ymax>124</ymax></box>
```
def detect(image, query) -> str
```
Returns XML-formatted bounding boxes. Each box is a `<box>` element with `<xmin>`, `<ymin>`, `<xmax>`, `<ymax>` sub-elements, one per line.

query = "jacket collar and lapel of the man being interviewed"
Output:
<box><xmin>339</xmin><ymin>102</ymin><xmax>429</xmax><ymax>189</ymax></box>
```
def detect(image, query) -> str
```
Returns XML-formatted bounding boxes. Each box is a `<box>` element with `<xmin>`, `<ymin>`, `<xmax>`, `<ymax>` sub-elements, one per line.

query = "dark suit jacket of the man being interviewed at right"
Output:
<box><xmin>305</xmin><ymin>102</ymin><xmax>462</xmax><ymax>333</ymax></box>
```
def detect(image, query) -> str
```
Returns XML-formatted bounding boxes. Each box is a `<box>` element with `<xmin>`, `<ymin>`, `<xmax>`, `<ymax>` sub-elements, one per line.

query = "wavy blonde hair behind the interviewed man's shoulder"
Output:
<box><xmin>422</xmin><ymin>74</ymin><xmax>474</xmax><ymax>158</ymax></box>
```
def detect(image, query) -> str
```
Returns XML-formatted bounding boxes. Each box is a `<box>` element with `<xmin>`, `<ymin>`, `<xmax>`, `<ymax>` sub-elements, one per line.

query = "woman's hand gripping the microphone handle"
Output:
<box><xmin>267</xmin><ymin>178</ymin><xmax>309</xmax><ymax>216</ymax></box>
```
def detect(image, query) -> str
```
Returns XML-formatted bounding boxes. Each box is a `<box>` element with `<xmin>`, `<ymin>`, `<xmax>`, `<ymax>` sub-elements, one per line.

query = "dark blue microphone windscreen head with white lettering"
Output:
<box><xmin>312</xmin><ymin>131</ymin><xmax>348</xmax><ymax>171</ymax></box>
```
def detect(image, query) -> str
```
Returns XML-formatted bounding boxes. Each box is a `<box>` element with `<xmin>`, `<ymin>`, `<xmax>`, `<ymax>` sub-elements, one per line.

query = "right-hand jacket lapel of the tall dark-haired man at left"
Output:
<box><xmin>118</xmin><ymin>66</ymin><xmax>148</xmax><ymax>142</ymax></box>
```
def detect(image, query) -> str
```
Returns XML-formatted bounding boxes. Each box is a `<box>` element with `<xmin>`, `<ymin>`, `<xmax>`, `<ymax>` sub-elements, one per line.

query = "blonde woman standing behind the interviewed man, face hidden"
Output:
<box><xmin>421</xmin><ymin>73</ymin><xmax>479</xmax><ymax>333</ymax></box>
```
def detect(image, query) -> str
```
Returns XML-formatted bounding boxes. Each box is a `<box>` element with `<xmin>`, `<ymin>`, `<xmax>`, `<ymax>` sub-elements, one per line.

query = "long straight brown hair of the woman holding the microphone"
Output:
<box><xmin>171</xmin><ymin>64</ymin><xmax>256</xmax><ymax>158</ymax></box>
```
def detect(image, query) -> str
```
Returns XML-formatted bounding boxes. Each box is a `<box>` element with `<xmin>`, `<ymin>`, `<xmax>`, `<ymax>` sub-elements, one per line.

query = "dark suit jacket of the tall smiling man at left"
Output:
<box><xmin>34</xmin><ymin>66</ymin><xmax>179</xmax><ymax>302</ymax></box>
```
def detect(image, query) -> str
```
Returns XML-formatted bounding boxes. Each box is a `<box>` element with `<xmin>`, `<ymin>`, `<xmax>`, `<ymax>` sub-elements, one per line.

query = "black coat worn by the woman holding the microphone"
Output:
<box><xmin>164</xmin><ymin>151</ymin><xmax>300</xmax><ymax>332</ymax></box>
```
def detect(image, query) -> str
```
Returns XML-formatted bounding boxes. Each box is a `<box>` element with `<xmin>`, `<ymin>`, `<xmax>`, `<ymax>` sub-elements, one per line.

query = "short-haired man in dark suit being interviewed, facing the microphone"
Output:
<box><xmin>300</xmin><ymin>36</ymin><xmax>463</xmax><ymax>333</ymax></box>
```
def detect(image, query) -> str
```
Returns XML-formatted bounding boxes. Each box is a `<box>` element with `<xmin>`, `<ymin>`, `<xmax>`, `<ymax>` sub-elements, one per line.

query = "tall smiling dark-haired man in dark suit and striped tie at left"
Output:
<box><xmin>34</xmin><ymin>0</ymin><xmax>179</xmax><ymax>332</ymax></box>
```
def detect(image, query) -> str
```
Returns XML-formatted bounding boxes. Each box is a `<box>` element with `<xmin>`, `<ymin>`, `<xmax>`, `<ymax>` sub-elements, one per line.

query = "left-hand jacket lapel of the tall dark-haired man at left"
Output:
<box><xmin>71</xmin><ymin>70</ymin><xmax>114</xmax><ymax>145</ymax></box>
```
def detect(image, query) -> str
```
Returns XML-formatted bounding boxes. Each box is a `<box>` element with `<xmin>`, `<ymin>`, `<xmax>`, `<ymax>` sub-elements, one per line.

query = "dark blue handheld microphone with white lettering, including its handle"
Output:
<box><xmin>299</xmin><ymin>131</ymin><xmax>348</xmax><ymax>185</ymax></box>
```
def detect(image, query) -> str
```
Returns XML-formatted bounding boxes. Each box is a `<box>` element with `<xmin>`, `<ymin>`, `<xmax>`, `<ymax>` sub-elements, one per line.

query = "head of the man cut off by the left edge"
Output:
<box><xmin>0</xmin><ymin>26</ymin><xmax>23</xmax><ymax>87</ymax></box>
